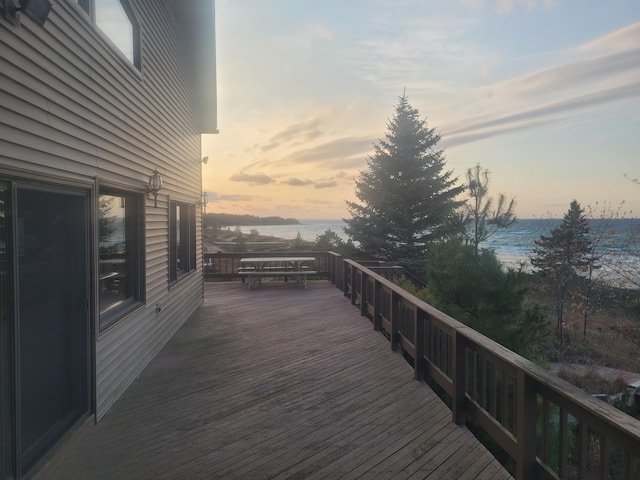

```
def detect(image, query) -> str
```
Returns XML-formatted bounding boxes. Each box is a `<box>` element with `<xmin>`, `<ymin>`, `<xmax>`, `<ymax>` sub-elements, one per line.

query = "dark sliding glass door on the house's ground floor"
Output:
<box><xmin>0</xmin><ymin>182</ymin><xmax>91</xmax><ymax>480</ymax></box>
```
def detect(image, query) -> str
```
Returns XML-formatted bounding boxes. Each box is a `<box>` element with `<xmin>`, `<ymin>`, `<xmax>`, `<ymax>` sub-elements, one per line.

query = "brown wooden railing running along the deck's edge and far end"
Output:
<box><xmin>205</xmin><ymin>252</ymin><xmax>640</xmax><ymax>480</ymax></box>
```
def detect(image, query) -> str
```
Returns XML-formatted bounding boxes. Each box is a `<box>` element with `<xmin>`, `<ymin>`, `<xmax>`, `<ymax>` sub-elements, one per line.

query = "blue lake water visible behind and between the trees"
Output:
<box><xmin>230</xmin><ymin>219</ymin><xmax>640</xmax><ymax>284</ymax></box>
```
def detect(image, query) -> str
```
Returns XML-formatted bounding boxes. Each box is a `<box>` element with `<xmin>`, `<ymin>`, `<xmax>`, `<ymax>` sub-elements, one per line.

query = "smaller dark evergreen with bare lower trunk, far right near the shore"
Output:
<box><xmin>531</xmin><ymin>200</ymin><xmax>596</xmax><ymax>343</ymax></box>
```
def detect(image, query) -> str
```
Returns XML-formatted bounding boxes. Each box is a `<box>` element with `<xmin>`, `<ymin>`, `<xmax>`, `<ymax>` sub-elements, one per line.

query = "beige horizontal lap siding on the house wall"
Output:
<box><xmin>0</xmin><ymin>0</ymin><xmax>204</xmax><ymax>416</ymax></box>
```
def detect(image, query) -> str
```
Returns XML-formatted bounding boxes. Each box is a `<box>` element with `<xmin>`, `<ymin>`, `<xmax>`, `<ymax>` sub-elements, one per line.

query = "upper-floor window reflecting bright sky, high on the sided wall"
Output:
<box><xmin>76</xmin><ymin>0</ymin><xmax>140</xmax><ymax>69</ymax></box>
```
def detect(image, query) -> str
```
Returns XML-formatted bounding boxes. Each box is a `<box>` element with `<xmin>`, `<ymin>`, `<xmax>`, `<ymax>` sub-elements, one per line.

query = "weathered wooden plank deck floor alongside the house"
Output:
<box><xmin>51</xmin><ymin>281</ymin><xmax>510</xmax><ymax>480</ymax></box>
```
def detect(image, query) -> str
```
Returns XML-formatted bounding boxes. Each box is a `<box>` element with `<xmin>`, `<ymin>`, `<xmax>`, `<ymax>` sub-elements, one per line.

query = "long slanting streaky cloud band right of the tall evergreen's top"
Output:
<box><xmin>441</xmin><ymin>24</ymin><xmax>640</xmax><ymax>146</ymax></box>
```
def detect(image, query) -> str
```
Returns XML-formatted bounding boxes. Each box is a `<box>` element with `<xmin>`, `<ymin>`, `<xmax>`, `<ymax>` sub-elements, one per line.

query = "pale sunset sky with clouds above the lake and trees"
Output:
<box><xmin>202</xmin><ymin>0</ymin><xmax>640</xmax><ymax>219</ymax></box>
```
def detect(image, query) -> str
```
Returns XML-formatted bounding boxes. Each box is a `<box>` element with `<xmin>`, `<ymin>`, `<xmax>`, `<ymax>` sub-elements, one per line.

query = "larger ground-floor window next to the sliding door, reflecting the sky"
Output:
<box><xmin>98</xmin><ymin>190</ymin><xmax>144</xmax><ymax>330</ymax></box>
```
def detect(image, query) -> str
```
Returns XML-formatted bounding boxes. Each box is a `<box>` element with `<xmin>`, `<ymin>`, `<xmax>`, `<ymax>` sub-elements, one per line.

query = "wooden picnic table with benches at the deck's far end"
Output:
<box><xmin>238</xmin><ymin>256</ymin><xmax>318</xmax><ymax>290</ymax></box>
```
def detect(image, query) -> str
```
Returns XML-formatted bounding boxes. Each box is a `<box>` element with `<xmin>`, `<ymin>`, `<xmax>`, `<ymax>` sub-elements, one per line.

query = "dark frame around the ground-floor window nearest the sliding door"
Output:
<box><xmin>96</xmin><ymin>185</ymin><xmax>146</xmax><ymax>333</ymax></box>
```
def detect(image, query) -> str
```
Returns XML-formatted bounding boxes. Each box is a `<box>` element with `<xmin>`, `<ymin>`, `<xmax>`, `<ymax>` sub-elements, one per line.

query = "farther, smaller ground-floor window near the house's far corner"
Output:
<box><xmin>169</xmin><ymin>202</ymin><xmax>196</xmax><ymax>283</ymax></box>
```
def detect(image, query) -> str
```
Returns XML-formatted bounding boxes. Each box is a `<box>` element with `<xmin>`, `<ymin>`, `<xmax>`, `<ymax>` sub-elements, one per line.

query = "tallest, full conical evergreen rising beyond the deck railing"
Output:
<box><xmin>345</xmin><ymin>94</ymin><xmax>464</xmax><ymax>259</ymax></box>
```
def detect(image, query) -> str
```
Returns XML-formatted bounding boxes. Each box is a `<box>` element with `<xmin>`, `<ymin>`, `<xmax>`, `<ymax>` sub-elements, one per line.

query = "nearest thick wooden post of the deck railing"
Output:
<box><xmin>515</xmin><ymin>370</ymin><xmax>537</xmax><ymax>480</ymax></box>
